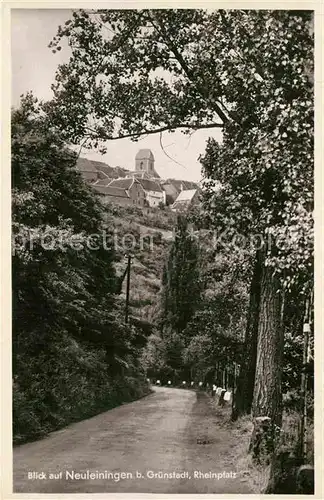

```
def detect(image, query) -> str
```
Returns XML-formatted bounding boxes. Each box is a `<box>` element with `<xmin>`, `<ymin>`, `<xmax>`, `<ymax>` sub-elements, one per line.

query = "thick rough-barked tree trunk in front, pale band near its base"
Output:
<box><xmin>250</xmin><ymin>260</ymin><xmax>284</xmax><ymax>461</ymax></box>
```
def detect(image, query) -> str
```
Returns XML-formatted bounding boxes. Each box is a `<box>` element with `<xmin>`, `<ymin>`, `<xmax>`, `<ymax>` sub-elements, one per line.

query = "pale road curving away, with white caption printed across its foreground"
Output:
<box><xmin>14</xmin><ymin>388</ymin><xmax>251</xmax><ymax>493</ymax></box>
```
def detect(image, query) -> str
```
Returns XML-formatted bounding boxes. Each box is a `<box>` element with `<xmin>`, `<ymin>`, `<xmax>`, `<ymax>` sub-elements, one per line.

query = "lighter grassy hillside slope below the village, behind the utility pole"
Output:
<box><xmin>106</xmin><ymin>205</ymin><xmax>176</xmax><ymax>326</ymax></box>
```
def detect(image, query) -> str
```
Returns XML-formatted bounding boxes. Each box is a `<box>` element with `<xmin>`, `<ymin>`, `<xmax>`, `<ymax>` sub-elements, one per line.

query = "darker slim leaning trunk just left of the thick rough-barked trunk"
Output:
<box><xmin>232</xmin><ymin>250</ymin><xmax>262</xmax><ymax>420</ymax></box>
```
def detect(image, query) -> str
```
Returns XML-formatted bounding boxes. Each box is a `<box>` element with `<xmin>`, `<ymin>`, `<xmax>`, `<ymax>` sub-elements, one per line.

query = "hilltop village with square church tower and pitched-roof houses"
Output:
<box><xmin>77</xmin><ymin>149</ymin><xmax>200</xmax><ymax>212</ymax></box>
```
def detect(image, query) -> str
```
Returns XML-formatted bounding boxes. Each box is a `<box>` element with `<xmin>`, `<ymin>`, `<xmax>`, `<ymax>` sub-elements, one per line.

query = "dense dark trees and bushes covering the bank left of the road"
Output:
<box><xmin>12</xmin><ymin>95</ymin><xmax>148</xmax><ymax>442</ymax></box>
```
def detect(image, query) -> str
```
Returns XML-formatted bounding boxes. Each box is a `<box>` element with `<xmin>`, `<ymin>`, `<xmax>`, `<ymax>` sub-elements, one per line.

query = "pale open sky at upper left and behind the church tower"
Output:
<box><xmin>11</xmin><ymin>9</ymin><xmax>221</xmax><ymax>181</ymax></box>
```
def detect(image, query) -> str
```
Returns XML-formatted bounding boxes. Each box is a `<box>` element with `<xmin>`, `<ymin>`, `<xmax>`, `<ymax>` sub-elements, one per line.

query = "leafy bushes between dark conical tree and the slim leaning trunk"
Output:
<box><xmin>183</xmin><ymin>242</ymin><xmax>248</xmax><ymax>382</ymax></box>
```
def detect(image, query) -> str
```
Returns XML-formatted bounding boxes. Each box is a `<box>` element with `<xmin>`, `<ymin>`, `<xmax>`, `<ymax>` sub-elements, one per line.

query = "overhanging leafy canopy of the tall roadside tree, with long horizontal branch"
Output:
<box><xmin>48</xmin><ymin>9</ymin><xmax>313</xmax><ymax>286</ymax></box>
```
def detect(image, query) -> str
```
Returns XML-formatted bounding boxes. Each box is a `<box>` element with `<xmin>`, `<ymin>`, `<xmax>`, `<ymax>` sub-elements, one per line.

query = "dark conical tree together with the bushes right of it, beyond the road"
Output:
<box><xmin>143</xmin><ymin>218</ymin><xmax>248</xmax><ymax>383</ymax></box>
